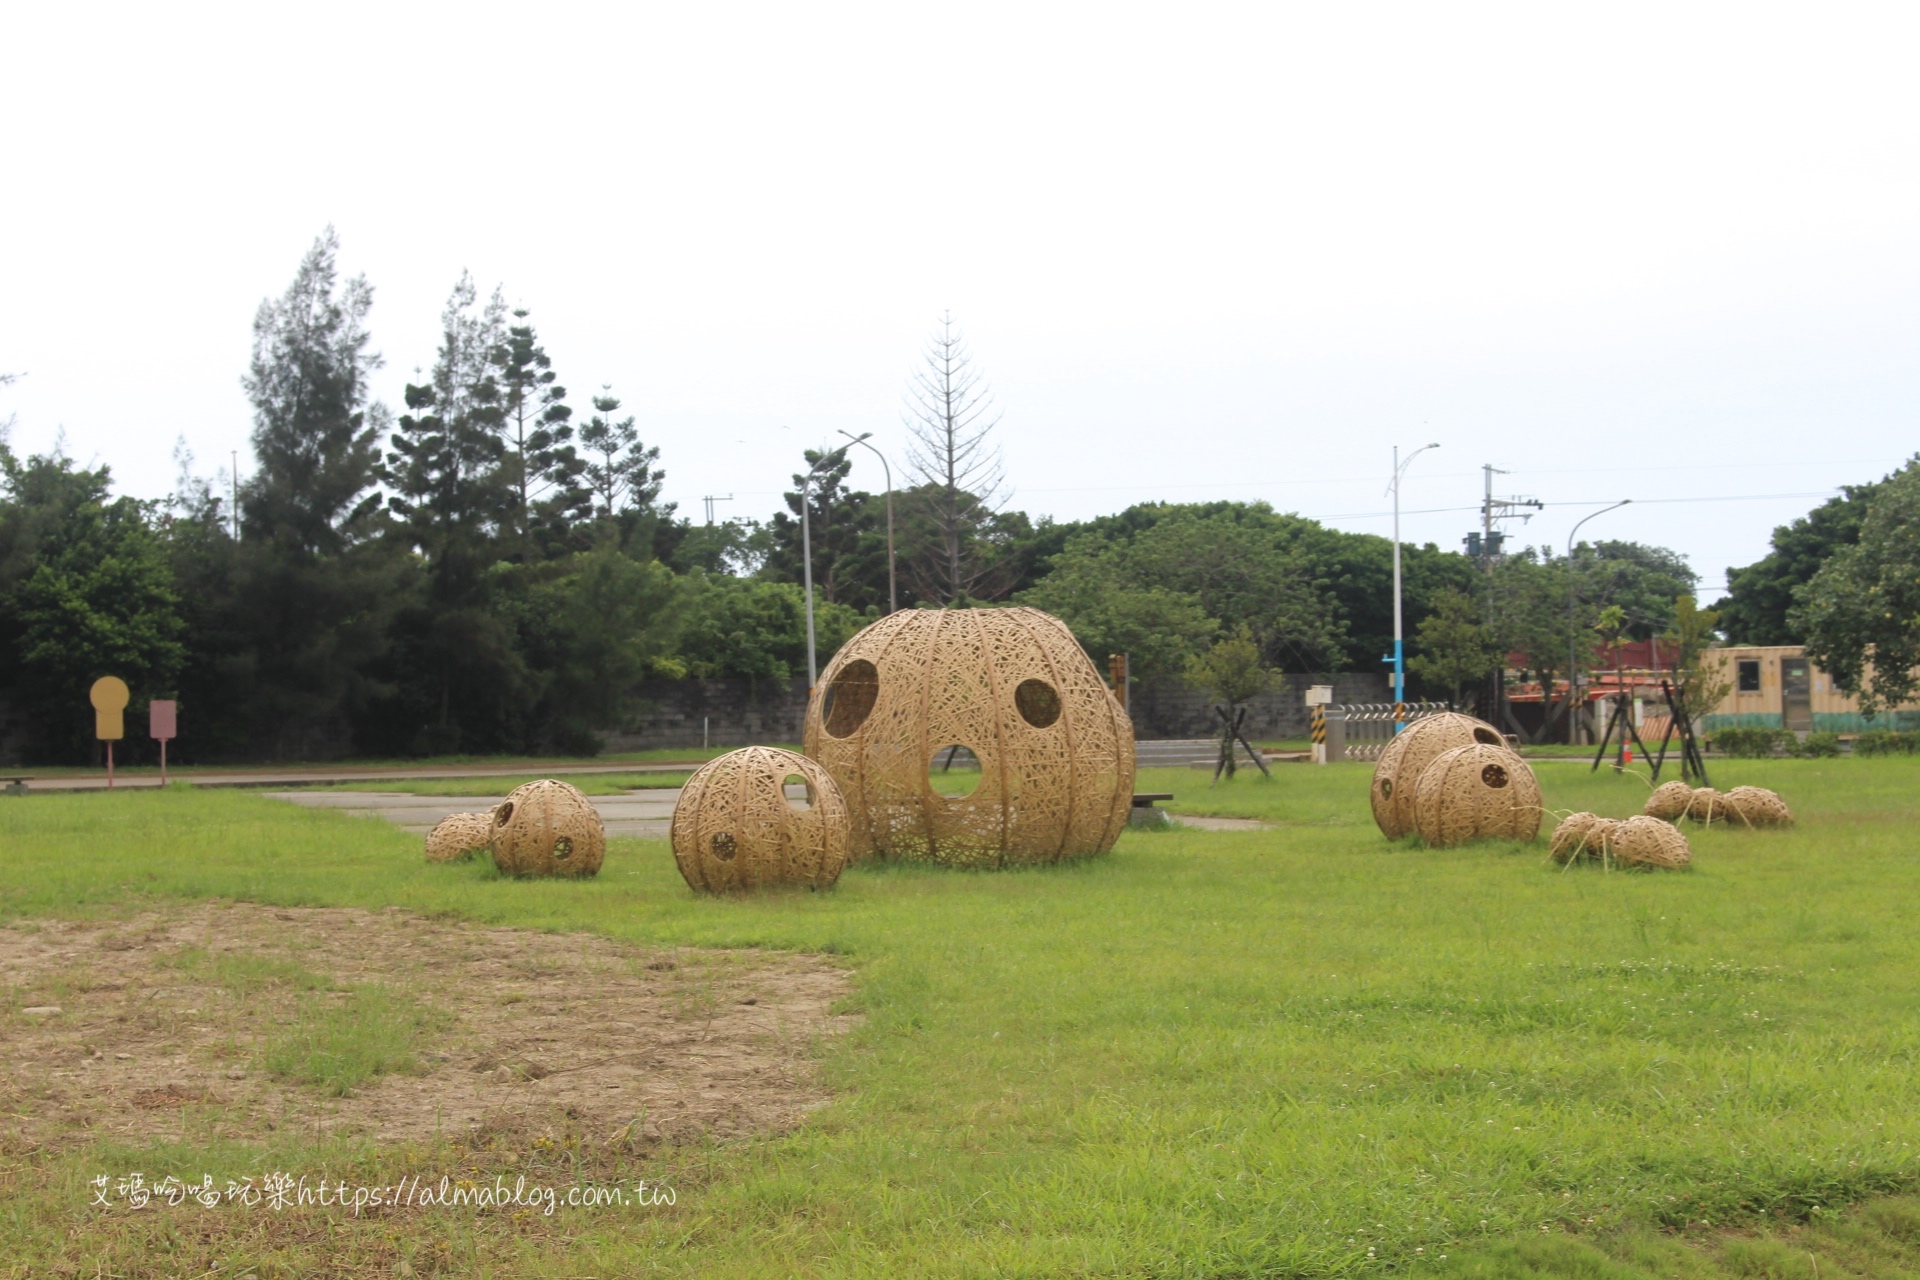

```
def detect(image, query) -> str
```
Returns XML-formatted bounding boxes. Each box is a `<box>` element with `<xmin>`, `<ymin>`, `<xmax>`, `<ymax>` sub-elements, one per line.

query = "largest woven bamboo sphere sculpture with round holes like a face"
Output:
<box><xmin>806</xmin><ymin>608</ymin><xmax>1133</xmax><ymax>867</ymax></box>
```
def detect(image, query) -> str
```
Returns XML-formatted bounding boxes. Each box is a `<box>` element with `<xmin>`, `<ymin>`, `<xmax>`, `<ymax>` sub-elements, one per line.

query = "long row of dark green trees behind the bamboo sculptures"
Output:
<box><xmin>0</xmin><ymin>232</ymin><xmax>1743</xmax><ymax>760</ymax></box>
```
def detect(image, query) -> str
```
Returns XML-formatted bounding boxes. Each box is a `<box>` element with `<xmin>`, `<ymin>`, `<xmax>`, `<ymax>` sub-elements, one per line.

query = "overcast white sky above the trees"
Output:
<box><xmin>0</xmin><ymin>2</ymin><xmax>1920</xmax><ymax>589</ymax></box>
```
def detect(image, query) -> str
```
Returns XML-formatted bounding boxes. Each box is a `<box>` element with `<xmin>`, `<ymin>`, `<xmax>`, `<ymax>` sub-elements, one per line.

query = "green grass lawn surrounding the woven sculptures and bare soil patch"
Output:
<box><xmin>0</xmin><ymin>760</ymin><xmax>1920</xmax><ymax>1280</ymax></box>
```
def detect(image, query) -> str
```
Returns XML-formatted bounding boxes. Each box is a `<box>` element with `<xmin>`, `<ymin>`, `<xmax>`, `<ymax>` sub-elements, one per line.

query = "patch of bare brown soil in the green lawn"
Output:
<box><xmin>0</xmin><ymin>904</ymin><xmax>852</xmax><ymax>1151</ymax></box>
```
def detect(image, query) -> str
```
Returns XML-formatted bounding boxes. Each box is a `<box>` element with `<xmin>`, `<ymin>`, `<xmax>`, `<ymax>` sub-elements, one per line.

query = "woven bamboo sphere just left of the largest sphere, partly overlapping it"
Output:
<box><xmin>672</xmin><ymin>747</ymin><xmax>847</xmax><ymax>892</ymax></box>
